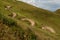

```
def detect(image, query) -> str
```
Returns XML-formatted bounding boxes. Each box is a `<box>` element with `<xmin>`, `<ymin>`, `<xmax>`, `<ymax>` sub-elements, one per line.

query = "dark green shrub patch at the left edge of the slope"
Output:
<box><xmin>0</xmin><ymin>13</ymin><xmax>16</xmax><ymax>26</ymax></box>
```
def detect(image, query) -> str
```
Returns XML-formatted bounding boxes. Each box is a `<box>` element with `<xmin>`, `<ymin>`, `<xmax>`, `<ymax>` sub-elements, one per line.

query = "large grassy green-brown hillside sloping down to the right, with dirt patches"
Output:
<box><xmin>0</xmin><ymin>0</ymin><xmax>60</xmax><ymax>40</ymax></box>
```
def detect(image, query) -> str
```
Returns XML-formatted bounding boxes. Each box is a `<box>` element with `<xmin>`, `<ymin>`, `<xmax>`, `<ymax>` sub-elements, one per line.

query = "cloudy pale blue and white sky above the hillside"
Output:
<box><xmin>17</xmin><ymin>0</ymin><xmax>60</xmax><ymax>11</ymax></box>
